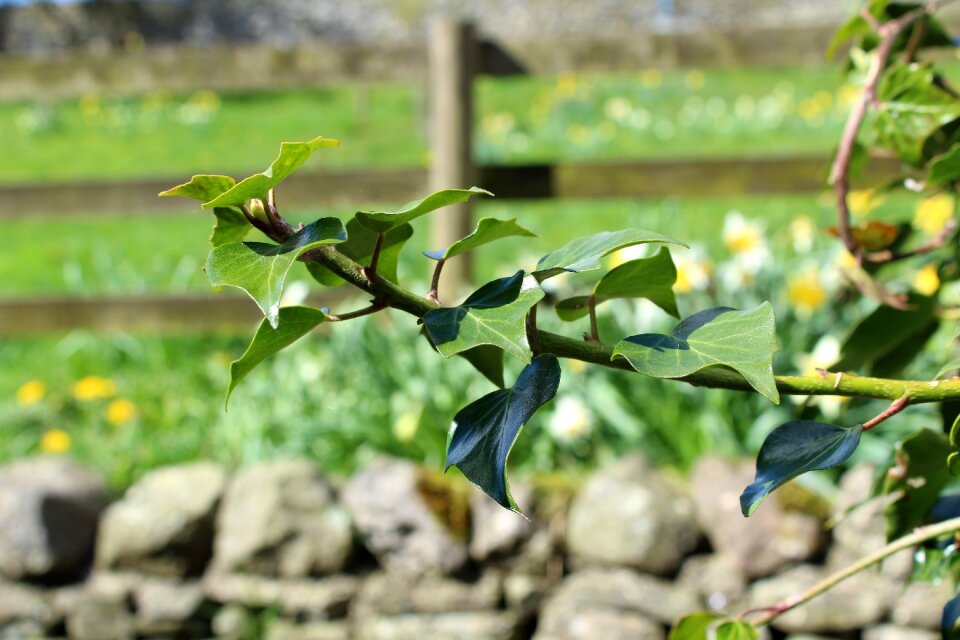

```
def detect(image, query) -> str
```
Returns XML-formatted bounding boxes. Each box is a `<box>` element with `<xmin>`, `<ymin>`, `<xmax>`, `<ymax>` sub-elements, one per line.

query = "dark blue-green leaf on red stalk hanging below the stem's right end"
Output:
<box><xmin>740</xmin><ymin>420</ymin><xmax>863</xmax><ymax>517</ymax></box>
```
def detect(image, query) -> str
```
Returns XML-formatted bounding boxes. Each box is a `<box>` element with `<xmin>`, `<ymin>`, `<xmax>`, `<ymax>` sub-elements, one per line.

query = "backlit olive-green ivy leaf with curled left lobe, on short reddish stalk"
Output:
<box><xmin>557</xmin><ymin>247</ymin><xmax>680</xmax><ymax>321</ymax></box>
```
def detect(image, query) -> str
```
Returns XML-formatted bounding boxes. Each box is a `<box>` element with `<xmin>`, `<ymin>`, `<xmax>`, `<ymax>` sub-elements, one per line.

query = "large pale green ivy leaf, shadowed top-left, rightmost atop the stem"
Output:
<box><xmin>613</xmin><ymin>302</ymin><xmax>780</xmax><ymax>403</ymax></box>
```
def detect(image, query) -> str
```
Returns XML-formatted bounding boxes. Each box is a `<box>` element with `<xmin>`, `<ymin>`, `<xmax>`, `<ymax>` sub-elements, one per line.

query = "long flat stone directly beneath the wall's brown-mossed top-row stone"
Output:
<box><xmin>351</xmin><ymin>572</ymin><xmax>503</xmax><ymax>620</ymax></box>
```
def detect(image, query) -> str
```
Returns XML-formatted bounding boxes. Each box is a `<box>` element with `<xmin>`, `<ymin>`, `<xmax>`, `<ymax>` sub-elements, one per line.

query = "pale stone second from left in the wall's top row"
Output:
<box><xmin>97</xmin><ymin>462</ymin><xmax>226</xmax><ymax>577</ymax></box>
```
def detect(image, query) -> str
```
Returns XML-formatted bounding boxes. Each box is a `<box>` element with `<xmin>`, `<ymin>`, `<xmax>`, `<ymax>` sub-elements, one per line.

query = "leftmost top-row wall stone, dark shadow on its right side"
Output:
<box><xmin>0</xmin><ymin>458</ymin><xmax>107</xmax><ymax>580</ymax></box>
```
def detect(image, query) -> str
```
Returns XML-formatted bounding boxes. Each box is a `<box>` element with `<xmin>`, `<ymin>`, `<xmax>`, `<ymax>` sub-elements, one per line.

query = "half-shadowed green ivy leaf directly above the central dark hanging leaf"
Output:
<box><xmin>423</xmin><ymin>271</ymin><xmax>543</xmax><ymax>362</ymax></box>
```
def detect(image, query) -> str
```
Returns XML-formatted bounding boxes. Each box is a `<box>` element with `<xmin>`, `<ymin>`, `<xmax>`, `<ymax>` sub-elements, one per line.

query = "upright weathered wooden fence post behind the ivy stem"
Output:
<box><xmin>429</xmin><ymin>17</ymin><xmax>478</xmax><ymax>304</ymax></box>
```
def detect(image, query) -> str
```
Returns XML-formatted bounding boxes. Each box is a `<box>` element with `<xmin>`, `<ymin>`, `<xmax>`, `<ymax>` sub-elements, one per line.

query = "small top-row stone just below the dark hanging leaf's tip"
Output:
<box><xmin>470</xmin><ymin>482</ymin><xmax>535</xmax><ymax>562</ymax></box>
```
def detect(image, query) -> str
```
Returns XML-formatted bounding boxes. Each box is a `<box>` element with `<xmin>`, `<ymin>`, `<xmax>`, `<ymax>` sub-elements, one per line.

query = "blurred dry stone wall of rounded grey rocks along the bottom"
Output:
<box><xmin>0</xmin><ymin>456</ymin><xmax>952</xmax><ymax>640</ymax></box>
